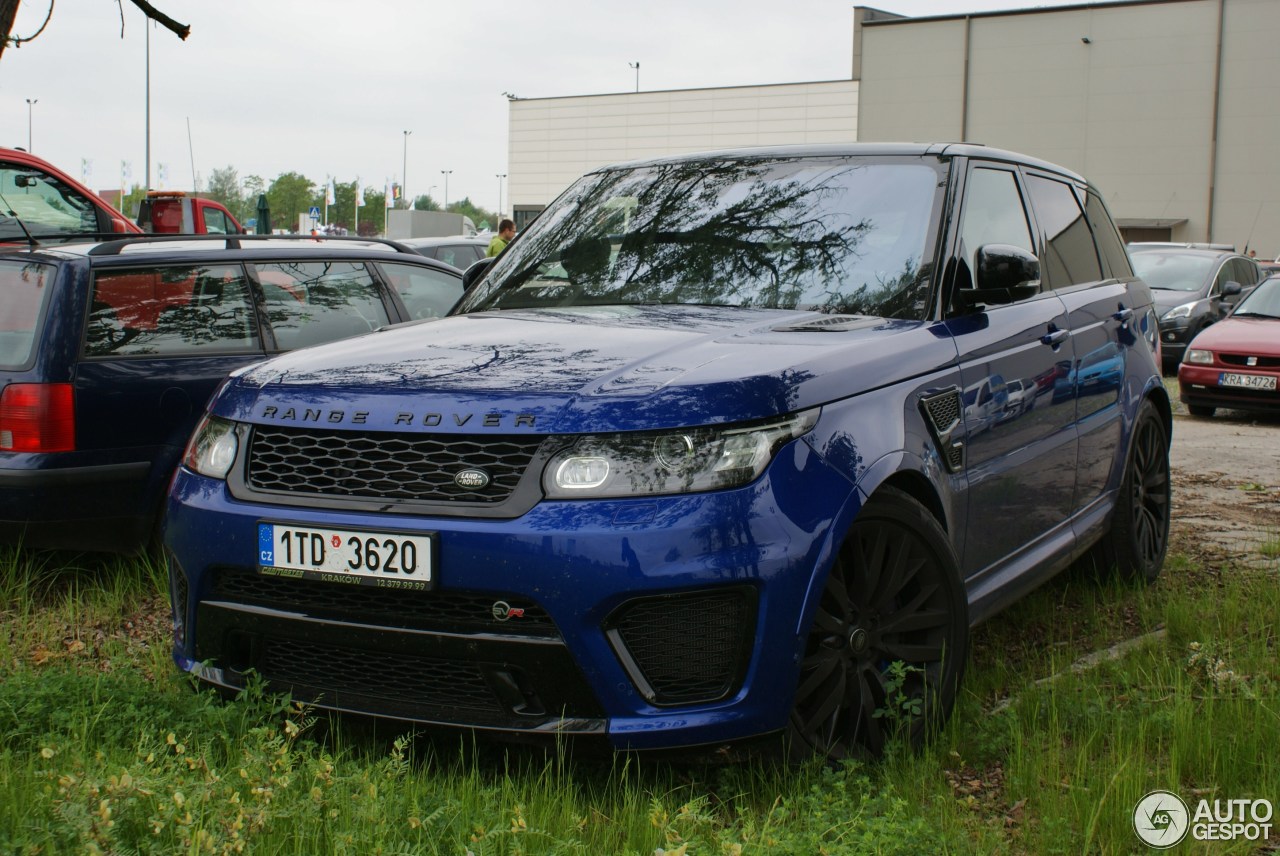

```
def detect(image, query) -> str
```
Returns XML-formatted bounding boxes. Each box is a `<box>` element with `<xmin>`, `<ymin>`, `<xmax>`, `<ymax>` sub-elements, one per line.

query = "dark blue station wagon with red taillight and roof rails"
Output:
<box><xmin>0</xmin><ymin>235</ymin><xmax>462</xmax><ymax>551</ymax></box>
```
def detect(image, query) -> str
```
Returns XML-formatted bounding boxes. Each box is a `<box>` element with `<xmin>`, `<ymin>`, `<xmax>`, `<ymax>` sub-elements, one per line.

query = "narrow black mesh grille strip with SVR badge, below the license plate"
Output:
<box><xmin>207</xmin><ymin>568</ymin><xmax>559</xmax><ymax>638</ymax></box>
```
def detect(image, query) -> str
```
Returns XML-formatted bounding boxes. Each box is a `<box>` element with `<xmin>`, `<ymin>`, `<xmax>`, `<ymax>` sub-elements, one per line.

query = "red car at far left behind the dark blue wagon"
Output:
<box><xmin>0</xmin><ymin>148</ymin><xmax>142</xmax><ymax>244</ymax></box>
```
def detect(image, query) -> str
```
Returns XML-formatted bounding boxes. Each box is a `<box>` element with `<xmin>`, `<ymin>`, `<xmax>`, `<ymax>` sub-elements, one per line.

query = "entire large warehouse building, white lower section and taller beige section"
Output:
<box><xmin>508</xmin><ymin>0</ymin><xmax>1280</xmax><ymax>257</ymax></box>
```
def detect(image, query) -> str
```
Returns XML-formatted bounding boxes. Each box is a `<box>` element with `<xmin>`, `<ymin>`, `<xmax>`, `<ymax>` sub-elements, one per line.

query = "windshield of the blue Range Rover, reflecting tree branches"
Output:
<box><xmin>458</xmin><ymin>157</ymin><xmax>946</xmax><ymax>319</ymax></box>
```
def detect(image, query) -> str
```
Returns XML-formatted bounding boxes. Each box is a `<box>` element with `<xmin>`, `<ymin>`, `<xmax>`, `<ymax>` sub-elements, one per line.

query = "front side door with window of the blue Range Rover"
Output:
<box><xmin>947</xmin><ymin>161</ymin><xmax>1076</xmax><ymax>583</ymax></box>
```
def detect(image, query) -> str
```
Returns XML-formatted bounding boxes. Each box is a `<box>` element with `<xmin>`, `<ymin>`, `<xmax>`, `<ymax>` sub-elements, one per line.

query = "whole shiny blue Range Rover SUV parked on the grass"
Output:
<box><xmin>164</xmin><ymin>145</ymin><xmax>1170</xmax><ymax>756</ymax></box>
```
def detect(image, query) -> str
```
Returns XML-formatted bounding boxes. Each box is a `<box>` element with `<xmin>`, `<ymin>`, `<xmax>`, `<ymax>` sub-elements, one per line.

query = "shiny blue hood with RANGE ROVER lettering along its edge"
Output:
<box><xmin>212</xmin><ymin>306</ymin><xmax>956</xmax><ymax>434</ymax></box>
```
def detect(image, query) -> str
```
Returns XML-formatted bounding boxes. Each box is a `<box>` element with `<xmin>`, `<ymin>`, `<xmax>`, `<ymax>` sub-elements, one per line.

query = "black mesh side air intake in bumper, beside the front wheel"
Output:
<box><xmin>611</xmin><ymin>589</ymin><xmax>755</xmax><ymax>704</ymax></box>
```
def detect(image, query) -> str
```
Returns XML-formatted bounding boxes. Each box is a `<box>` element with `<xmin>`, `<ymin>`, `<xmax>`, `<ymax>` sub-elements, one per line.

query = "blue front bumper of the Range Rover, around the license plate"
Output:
<box><xmin>165</xmin><ymin>443</ymin><xmax>856</xmax><ymax>749</ymax></box>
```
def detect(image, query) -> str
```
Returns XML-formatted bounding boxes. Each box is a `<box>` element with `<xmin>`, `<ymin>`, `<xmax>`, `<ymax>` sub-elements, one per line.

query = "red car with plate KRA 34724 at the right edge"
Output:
<box><xmin>1178</xmin><ymin>276</ymin><xmax>1280</xmax><ymax>416</ymax></box>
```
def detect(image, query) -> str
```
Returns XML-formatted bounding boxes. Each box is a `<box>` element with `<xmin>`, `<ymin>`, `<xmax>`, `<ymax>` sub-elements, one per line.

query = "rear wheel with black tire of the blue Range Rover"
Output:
<box><xmin>1106</xmin><ymin>399</ymin><xmax>1171</xmax><ymax>582</ymax></box>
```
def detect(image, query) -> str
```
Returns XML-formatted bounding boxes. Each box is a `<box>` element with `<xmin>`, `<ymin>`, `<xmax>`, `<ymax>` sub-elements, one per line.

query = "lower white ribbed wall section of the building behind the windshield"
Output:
<box><xmin>507</xmin><ymin>81</ymin><xmax>858</xmax><ymax>212</ymax></box>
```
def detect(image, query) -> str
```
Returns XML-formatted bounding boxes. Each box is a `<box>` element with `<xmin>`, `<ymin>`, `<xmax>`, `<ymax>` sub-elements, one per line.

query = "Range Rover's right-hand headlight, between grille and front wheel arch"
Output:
<box><xmin>543</xmin><ymin>409</ymin><xmax>818</xmax><ymax>499</ymax></box>
